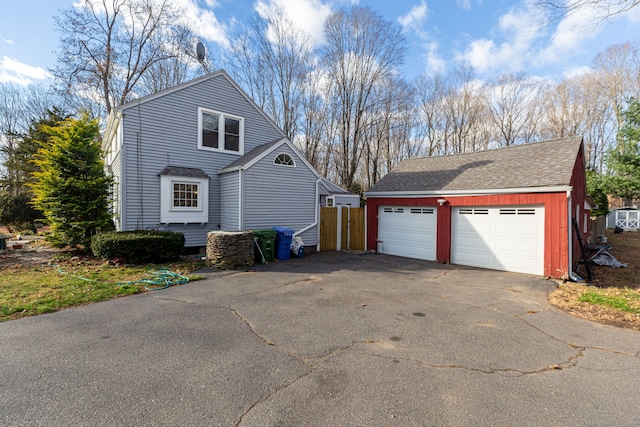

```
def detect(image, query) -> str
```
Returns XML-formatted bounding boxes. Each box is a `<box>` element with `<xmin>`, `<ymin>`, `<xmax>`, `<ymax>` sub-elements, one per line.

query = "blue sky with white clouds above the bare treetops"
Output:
<box><xmin>0</xmin><ymin>0</ymin><xmax>640</xmax><ymax>85</ymax></box>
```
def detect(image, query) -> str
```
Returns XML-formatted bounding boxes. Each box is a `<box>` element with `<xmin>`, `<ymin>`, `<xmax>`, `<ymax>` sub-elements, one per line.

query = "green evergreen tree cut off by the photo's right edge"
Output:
<box><xmin>606</xmin><ymin>99</ymin><xmax>640</xmax><ymax>204</ymax></box>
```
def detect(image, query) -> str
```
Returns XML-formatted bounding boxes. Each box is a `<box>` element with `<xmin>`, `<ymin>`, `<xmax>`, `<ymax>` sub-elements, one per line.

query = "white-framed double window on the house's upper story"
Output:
<box><xmin>198</xmin><ymin>108</ymin><xmax>244</xmax><ymax>154</ymax></box>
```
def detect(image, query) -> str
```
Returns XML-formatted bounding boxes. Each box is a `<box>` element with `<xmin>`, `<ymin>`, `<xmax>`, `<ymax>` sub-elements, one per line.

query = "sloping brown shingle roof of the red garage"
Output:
<box><xmin>366</xmin><ymin>136</ymin><xmax>582</xmax><ymax>196</ymax></box>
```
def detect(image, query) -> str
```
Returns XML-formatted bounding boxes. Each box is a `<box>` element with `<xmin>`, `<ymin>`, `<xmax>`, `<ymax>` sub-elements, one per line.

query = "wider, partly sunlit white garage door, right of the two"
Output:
<box><xmin>451</xmin><ymin>206</ymin><xmax>544</xmax><ymax>275</ymax></box>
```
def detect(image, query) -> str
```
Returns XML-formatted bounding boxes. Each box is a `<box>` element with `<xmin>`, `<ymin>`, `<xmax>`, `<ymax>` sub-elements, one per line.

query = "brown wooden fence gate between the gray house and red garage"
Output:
<box><xmin>320</xmin><ymin>206</ymin><xmax>365</xmax><ymax>251</ymax></box>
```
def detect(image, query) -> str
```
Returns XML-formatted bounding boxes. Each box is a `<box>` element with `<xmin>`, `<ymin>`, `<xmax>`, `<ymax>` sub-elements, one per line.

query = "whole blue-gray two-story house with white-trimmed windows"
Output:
<box><xmin>103</xmin><ymin>70</ymin><xmax>332</xmax><ymax>247</ymax></box>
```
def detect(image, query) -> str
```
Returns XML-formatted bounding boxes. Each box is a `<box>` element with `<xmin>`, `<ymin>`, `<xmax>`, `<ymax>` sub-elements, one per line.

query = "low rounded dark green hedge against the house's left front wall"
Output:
<box><xmin>91</xmin><ymin>230</ymin><xmax>184</xmax><ymax>264</ymax></box>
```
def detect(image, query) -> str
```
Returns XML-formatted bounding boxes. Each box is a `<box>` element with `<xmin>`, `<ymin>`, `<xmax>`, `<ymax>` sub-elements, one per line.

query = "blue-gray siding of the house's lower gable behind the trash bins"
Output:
<box><xmin>242</xmin><ymin>144</ymin><xmax>318</xmax><ymax>246</ymax></box>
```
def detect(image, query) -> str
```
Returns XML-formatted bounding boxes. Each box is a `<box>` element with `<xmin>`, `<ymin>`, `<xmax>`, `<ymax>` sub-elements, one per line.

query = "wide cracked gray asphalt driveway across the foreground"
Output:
<box><xmin>0</xmin><ymin>253</ymin><xmax>640</xmax><ymax>426</ymax></box>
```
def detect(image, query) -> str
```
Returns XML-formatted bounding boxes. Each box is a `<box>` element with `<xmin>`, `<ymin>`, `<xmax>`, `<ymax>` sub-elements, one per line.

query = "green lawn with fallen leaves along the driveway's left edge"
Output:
<box><xmin>0</xmin><ymin>262</ymin><xmax>204</xmax><ymax>321</ymax></box>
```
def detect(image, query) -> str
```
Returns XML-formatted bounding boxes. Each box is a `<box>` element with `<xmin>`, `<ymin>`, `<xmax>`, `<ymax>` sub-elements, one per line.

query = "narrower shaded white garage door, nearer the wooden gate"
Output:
<box><xmin>378</xmin><ymin>206</ymin><xmax>436</xmax><ymax>261</ymax></box>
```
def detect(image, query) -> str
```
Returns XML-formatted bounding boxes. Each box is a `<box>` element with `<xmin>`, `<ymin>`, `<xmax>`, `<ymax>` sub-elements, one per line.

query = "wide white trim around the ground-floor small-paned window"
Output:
<box><xmin>160</xmin><ymin>175</ymin><xmax>209</xmax><ymax>224</ymax></box>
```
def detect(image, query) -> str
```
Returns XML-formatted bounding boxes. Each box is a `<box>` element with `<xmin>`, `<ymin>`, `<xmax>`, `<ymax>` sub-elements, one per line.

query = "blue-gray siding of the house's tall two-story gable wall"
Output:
<box><xmin>119</xmin><ymin>74</ymin><xmax>282</xmax><ymax>246</ymax></box>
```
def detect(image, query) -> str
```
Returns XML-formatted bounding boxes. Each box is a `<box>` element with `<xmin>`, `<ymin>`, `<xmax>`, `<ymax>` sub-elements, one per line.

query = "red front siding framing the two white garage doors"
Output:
<box><xmin>367</xmin><ymin>192</ymin><xmax>572</xmax><ymax>277</ymax></box>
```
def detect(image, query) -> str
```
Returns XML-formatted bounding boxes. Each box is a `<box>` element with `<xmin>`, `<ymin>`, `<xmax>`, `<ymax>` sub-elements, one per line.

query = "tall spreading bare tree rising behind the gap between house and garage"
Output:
<box><xmin>323</xmin><ymin>7</ymin><xmax>406</xmax><ymax>188</ymax></box>
